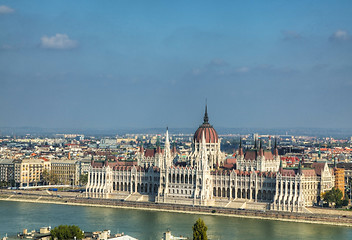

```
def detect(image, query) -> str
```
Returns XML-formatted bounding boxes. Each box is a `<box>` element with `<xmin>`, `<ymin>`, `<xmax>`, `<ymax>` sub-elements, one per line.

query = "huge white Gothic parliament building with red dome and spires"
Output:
<box><xmin>86</xmin><ymin>107</ymin><xmax>335</xmax><ymax>212</ymax></box>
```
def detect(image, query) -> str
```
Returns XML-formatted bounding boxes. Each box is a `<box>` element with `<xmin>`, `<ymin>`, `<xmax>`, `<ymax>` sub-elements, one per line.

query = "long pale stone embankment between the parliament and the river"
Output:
<box><xmin>0</xmin><ymin>192</ymin><xmax>352</xmax><ymax>227</ymax></box>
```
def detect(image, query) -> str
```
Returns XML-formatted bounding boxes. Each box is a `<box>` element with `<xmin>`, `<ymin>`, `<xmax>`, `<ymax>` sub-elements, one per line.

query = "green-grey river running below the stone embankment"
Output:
<box><xmin>0</xmin><ymin>201</ymin><xmax>352</xmax><ymax>240</ymax></box>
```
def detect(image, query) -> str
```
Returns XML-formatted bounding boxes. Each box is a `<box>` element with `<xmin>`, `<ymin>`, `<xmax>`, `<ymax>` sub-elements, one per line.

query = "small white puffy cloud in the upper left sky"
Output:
<box><xmin>41</xmin><ymin>33</ymin><xmax>78</xmax><ymax>49</ymax></box>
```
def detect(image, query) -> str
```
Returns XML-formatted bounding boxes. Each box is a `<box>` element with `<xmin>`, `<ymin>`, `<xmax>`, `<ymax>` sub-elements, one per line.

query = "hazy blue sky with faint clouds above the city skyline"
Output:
<box><xmin>0</xmin><ymin>0</ymin><xmax>352</xmax><ymax>128</ymax></box>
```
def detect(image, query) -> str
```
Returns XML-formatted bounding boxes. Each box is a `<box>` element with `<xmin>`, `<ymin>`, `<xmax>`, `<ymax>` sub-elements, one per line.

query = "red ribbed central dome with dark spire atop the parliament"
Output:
<box><xmin>193</xmin><ymin>106</ymin><xmax>219</xmax><ymax>143</ymax></box>
